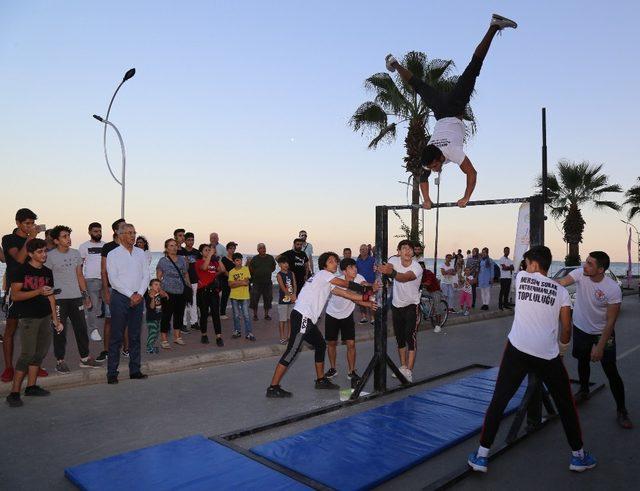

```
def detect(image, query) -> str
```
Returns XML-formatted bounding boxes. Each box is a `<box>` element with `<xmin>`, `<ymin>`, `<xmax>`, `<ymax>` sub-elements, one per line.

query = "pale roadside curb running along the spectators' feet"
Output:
<box><xmin>0</xmin><ymin>311</ymin><xmax>513</xmax><ymax>396</ymax></box>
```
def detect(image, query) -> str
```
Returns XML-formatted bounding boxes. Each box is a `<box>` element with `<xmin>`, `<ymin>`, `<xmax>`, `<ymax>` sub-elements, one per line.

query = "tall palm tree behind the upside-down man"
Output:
<box><xmin>349</xmin><ymin>51</ymin><xmax>476</xmax><ymax>241</ymax></box>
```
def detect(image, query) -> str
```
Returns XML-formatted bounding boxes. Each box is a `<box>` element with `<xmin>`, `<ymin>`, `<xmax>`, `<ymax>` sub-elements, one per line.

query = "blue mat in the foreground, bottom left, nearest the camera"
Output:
<box><xmin>65</xmin><ymin>435</ymin><xmax>310</xmax><ymax>491</ymax></box>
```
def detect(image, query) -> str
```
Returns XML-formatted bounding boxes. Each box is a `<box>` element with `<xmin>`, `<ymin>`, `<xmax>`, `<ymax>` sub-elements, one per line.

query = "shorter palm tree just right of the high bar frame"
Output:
<box><xmin>538</xmin><ymin>160</ymin><xmax>622</xmax><ymax>266</ymax></box>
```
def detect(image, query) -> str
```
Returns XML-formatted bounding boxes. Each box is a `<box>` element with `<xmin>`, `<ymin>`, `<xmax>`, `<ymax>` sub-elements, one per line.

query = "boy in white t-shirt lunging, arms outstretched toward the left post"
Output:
<box><xmin>266</xmin><ymin>252</ymin><xmax>376</xmax><ymax>397</ymax></box>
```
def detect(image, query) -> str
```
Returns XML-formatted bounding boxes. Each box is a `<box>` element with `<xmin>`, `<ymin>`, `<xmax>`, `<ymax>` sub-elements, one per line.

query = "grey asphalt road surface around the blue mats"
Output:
<box><xmin>0</xmin><ymin>297</ymin><xmax>640</xmax><ymax>490</ymax></box>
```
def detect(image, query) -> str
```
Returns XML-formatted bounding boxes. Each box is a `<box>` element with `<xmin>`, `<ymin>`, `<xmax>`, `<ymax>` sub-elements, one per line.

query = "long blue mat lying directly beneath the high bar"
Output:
<box><xmin>251</xmin><ymin>368</ymin><xmax>526</xmax><ymax>491</ymax></box>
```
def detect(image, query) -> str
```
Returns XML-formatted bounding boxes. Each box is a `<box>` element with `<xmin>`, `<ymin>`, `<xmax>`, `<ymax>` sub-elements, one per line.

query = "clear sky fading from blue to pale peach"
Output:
<box><xmin>0</xmin><ymin>0</ymin><xmax>640</xmax><ymax>261</ymax></box>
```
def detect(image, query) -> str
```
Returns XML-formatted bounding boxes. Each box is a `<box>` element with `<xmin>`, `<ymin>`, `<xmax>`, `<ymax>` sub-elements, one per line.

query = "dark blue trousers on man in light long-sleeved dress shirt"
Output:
<box><xmin>107</xmin><ymin>290</ymin><xmax>143</xmax><ymax>375</ymax></box>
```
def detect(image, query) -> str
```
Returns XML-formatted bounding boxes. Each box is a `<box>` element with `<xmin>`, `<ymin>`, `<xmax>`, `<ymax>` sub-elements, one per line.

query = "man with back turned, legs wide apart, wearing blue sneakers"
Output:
<box><xmin>467</xmin><ymin>246</ymin><xmax>596</xmax><ymax>472</ymax></box>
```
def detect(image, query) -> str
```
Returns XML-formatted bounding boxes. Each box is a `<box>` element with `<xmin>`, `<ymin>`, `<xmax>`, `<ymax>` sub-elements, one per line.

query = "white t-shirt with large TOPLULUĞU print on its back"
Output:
<box><xmin>509</xmin><ymin>271</ymin><xmax>571</xmax><ymax>360</ymax></box>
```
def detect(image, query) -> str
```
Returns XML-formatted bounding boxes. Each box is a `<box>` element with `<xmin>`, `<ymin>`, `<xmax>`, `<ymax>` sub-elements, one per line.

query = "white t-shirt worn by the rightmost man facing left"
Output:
<box><xmin>569</xmin><ymin>268</ymin><xmax>622</xmax><ymax>334</ymax></box>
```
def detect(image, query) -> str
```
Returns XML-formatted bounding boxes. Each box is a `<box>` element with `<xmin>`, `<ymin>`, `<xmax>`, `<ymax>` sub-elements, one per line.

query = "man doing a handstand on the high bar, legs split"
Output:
<box><xmin>386</xmin><ymin>14</ymin><xmax>518</xmax><ymax>209</ymax></box>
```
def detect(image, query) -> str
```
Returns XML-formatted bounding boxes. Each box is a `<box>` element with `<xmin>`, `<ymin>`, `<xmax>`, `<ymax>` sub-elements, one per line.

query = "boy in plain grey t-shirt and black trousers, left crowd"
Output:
<box><xmin>45</xmin><ymin>225</ymin><xmax>100</xmax><ymax>374</ymax></box>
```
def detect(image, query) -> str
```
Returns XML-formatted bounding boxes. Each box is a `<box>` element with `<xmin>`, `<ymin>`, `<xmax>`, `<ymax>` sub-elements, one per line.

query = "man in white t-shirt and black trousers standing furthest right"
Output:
<box><xmin>560</xmin><ymin>251</ymin><xmax>633</xmax><ymax>429</ymax></box>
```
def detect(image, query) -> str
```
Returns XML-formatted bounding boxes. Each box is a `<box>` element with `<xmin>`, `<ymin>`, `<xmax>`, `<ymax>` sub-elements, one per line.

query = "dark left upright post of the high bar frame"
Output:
<box><xmin>373</xmin><ymin>206</ymin><xmax>389</xmax><ymax>392</ymax></box>
